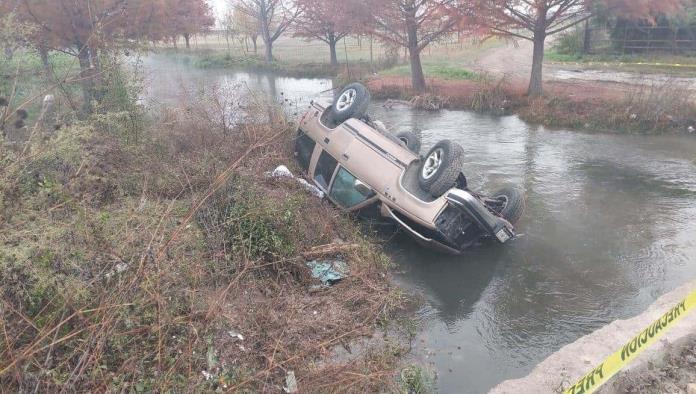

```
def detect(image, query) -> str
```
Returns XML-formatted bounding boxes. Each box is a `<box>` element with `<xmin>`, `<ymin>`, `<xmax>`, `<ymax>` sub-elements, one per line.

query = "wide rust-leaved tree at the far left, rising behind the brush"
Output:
<box><xmin>13</xmin><ymin>0</ymin><xmax>213</xmax><ymax>112</ymax></box>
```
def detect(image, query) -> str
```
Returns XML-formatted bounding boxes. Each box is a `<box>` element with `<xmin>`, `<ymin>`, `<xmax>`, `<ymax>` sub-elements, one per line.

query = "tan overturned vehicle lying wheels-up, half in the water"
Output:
<box><xmin>295</xmin><ymin>83</ymin><xmax>524</xmax><ymax>254</ymax></box>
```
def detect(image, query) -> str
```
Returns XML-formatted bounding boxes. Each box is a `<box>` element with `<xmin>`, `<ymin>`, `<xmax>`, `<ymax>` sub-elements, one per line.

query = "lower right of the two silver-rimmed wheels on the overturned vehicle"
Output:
<box><xmin>418</xmin><ymin>140</ymin><xmax>464</xmax><ymax>197</ymax></box>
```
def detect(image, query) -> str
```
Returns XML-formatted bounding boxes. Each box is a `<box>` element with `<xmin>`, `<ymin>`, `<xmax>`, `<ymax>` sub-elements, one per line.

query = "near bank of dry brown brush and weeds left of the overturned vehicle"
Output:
<box><xmin>0</xmin><ymin>84</ymin><xmax>422</xmax><ymax>392</ymax></box>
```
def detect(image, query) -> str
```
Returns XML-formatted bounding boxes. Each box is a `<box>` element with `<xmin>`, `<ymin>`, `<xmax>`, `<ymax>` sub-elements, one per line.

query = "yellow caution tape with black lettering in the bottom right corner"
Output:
<box><xmin>564</xmin><ymin>291</ymin><xmax>696</xmax><ymax>394</ymax></box>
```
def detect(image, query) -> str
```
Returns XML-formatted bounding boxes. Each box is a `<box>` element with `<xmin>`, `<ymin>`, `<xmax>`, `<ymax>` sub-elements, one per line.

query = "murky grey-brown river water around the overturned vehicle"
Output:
<box><xmin>141</xmin><ymin>58</ymin><xmax>696</xmax><ymax>393</ymax></box>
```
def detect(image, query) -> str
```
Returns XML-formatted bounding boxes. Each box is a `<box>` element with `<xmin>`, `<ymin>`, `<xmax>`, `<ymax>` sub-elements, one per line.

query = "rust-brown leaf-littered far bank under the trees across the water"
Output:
<box><xmin>367</xmin><ymin>76</ymin><xmax>696</xmax><ymax>134</ymax></box>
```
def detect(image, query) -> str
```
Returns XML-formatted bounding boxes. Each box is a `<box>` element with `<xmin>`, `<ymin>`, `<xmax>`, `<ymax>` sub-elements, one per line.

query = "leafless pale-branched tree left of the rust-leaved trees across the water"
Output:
<box><xmin>239</xmin><ymin>0</ymin><xmax>301</xmax><ymax>63</ymax></box>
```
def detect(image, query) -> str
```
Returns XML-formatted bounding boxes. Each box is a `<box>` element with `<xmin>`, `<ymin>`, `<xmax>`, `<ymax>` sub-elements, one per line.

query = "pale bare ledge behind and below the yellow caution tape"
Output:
<box><xmin>491</xmin><ymin>281</ymin><xmax>696</xmax><ymax>394</ymax></box>
